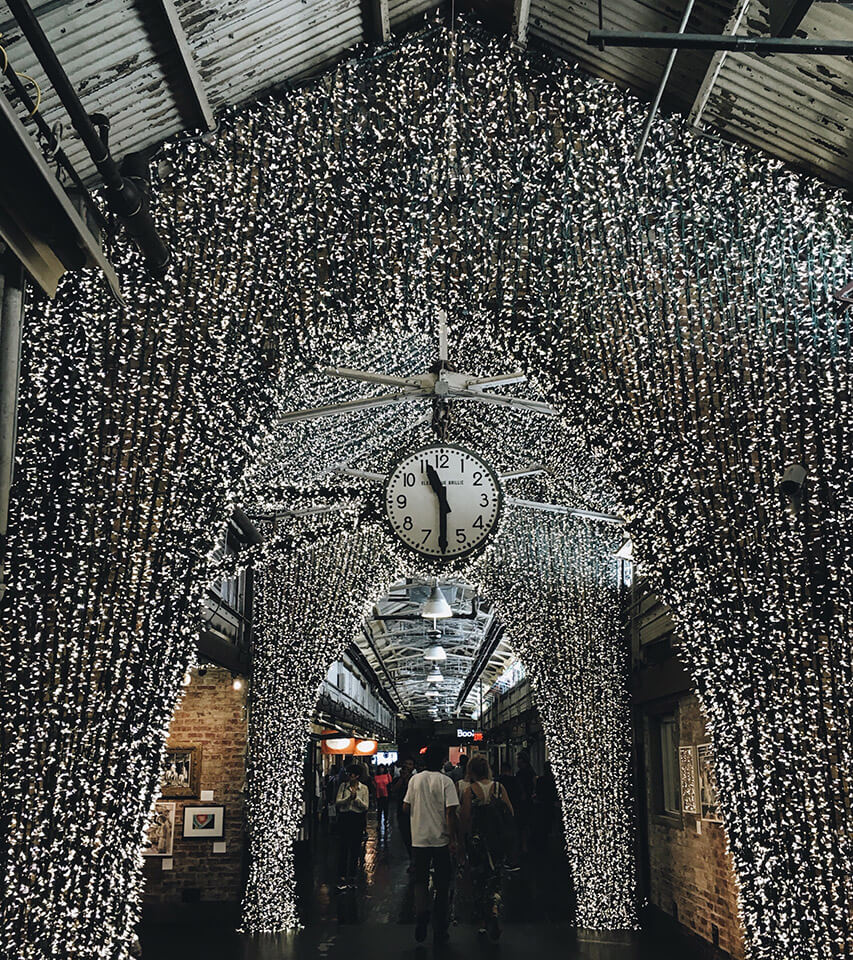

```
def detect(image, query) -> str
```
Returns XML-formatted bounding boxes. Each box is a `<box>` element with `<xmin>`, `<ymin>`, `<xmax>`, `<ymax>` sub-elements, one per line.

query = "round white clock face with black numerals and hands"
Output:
<box><xmin>385</xmin><ymin>443</ymin><xmax>503</xmax><ymax>559</ymax></box>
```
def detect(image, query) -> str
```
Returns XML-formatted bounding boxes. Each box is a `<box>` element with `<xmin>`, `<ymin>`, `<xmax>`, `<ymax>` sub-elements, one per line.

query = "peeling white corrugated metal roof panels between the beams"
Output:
<box><xmin>0</xmin><ymin>0</ymin><xmax>853</xmax><ymax>185</ymax></box>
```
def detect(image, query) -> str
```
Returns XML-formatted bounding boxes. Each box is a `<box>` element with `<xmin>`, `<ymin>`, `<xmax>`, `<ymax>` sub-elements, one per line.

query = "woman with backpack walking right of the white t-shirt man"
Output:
<box><xmin>460</xmin><ymin>753</ymin><xmax>514</xmax><ymax>940</ymax></box>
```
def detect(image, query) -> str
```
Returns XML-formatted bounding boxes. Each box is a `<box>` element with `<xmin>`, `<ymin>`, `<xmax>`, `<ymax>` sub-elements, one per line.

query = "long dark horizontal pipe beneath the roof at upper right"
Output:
<box><xmin>587</xmin><ymin>30</ymin><xmax>853</xmax><ymax>57</ymax></box>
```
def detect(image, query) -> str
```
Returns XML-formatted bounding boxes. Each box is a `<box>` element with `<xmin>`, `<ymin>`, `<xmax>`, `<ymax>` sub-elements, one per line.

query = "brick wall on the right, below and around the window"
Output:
<box><xmin>646</xmin><ymin>694</ymin><xmax>744</xmax><ymax>960</ymax></box>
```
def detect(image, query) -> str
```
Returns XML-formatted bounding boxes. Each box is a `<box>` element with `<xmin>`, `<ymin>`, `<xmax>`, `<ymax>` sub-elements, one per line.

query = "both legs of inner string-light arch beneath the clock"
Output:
<box><xmin>238</xmin><ymin>510</ymin><xmax>636</xmax><ymax>933</ymax></box>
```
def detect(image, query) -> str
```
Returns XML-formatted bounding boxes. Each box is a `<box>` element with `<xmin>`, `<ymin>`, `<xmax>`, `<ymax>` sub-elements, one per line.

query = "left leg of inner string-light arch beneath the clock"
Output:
<box><xmin>243</xmin><ymin>517</ymin><xmax>398</xmax><ymax>933</ymax></box>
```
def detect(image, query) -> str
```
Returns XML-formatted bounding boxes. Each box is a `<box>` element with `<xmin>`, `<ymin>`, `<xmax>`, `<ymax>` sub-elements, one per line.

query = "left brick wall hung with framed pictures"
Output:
<box><xmin>145</xmin><ymin>667</ymin><xmax>246</xmax><ymax>908</ymax></box>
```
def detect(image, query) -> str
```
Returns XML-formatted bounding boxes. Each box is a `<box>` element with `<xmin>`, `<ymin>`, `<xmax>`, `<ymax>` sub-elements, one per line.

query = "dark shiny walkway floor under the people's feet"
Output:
<box><xmin>141</xmin><ymin>808</ymin><xmax>701</xmax><ymax>960</ymax></box>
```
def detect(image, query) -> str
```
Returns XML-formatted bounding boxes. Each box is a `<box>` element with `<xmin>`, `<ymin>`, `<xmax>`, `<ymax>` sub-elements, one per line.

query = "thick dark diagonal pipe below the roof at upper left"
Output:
<box><xmin>8</xmin><ymin>0</ymin><xmax>171</xmax><ymax>279</ymax></box>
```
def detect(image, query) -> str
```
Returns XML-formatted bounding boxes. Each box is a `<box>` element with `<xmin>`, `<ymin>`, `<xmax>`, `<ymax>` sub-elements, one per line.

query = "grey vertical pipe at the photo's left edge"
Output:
<box><xmin>0</xmin><ymin>253</ymin><xmax>25</xmax><ymax>602</ymax></box>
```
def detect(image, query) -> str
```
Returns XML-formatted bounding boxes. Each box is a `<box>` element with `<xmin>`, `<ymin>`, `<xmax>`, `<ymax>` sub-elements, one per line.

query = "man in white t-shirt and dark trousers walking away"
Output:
<box><xmin>403</xmin><ymin>744</ymin><xmax>459</xmax><ymax>943</ymax></box>
